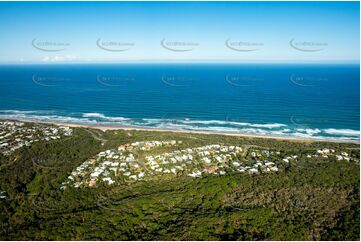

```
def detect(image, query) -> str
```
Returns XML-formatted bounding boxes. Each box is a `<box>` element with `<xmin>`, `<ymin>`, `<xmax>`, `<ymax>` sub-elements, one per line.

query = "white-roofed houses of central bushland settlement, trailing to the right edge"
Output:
<box><xmin>61</xmin><ymin>140</ymin><xmax>359</xmax><ymax>189</ymax></box>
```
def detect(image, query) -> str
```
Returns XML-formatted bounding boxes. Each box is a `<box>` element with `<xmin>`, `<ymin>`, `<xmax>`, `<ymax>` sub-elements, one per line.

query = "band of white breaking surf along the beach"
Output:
<box><xmin>0</xmin><ymin>110</ymin><xmax>360</xmax><ymax>141</ymax></box>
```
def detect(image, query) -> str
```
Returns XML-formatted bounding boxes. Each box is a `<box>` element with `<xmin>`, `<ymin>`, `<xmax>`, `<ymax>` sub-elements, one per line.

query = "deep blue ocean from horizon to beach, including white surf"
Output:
<box><xmin>0</xmin><ymin>64</ymin><xmax>360</xmax><ymax>141</ymax></box>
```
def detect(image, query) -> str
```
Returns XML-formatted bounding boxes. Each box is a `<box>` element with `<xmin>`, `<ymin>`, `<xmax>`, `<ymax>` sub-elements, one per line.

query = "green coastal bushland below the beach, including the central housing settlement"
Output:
<box><xmin>0</xmin><ymin>120</ymin><xmax>360</xmax><ymax>240</ymax></box>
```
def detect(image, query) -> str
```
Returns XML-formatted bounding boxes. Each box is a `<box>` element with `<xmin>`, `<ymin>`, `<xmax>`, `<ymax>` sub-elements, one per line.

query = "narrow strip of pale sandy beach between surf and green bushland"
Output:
<box><xmin>4</xmin><ymin>118</ymin><xmax>360</xmax><ymax>144</ymax></box>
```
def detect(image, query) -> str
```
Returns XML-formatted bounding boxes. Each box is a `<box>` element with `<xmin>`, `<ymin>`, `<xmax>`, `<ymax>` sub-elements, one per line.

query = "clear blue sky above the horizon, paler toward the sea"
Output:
<box><xmin>0</xmin><ymin>2</ymin><xmax>360</xmax><ymax>63</ymax></box>
